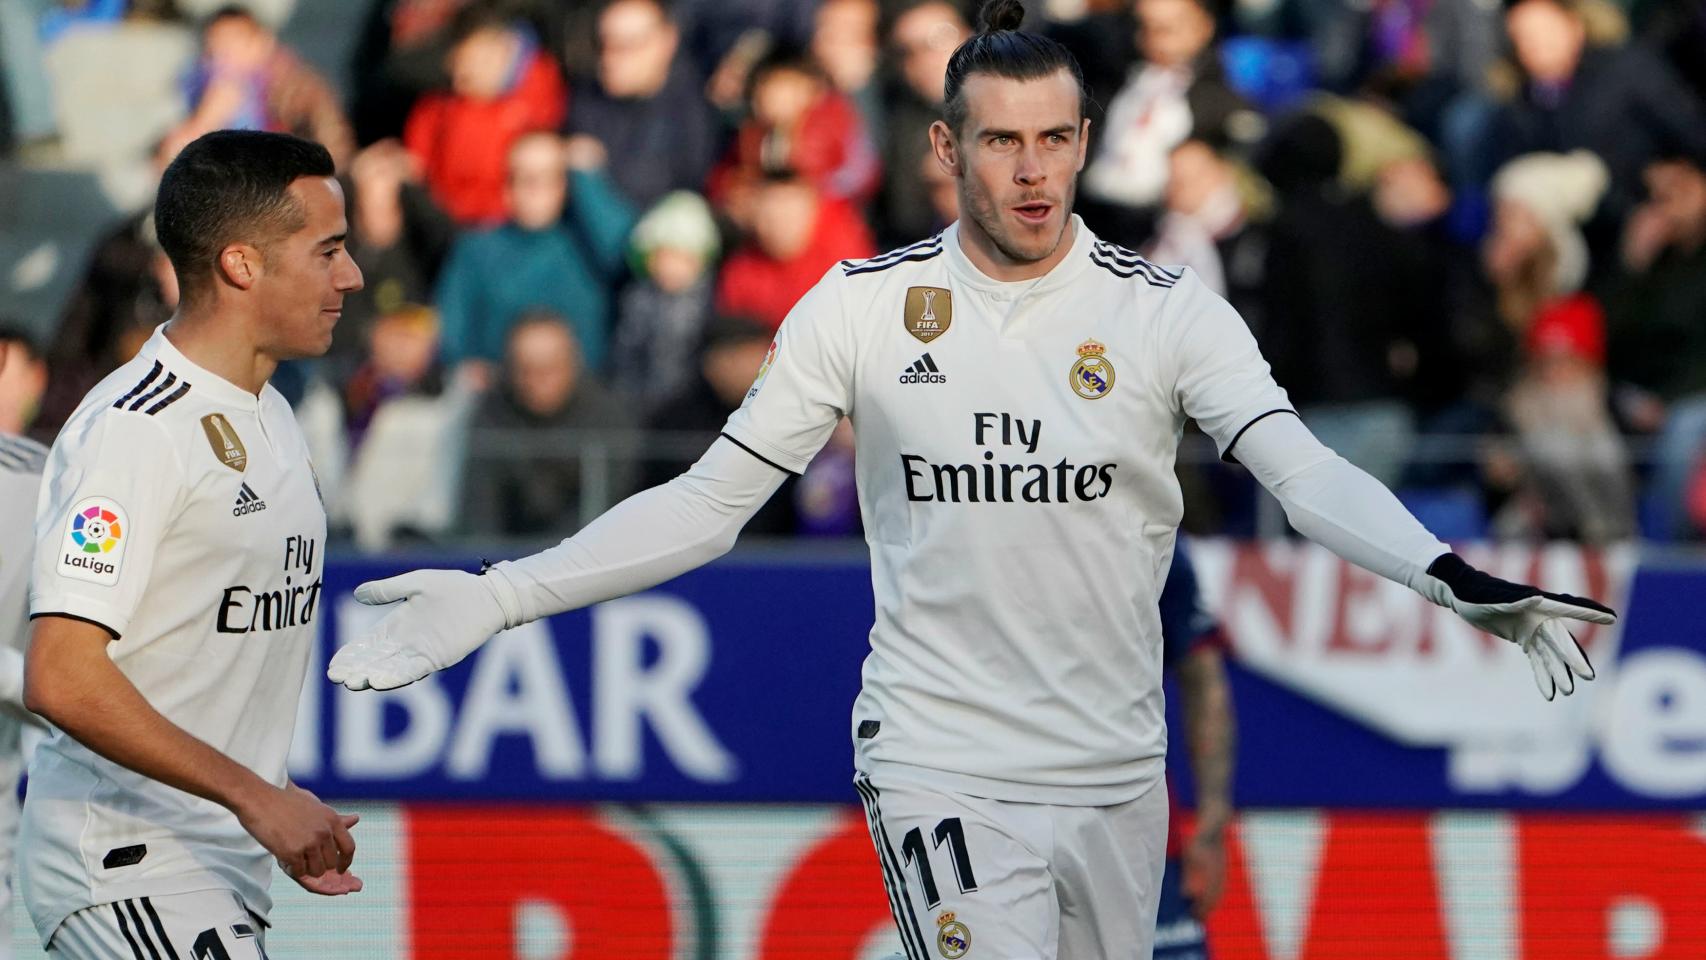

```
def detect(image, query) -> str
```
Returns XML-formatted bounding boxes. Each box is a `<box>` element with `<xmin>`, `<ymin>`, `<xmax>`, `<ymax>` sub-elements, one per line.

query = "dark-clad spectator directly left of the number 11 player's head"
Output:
<box><xmin>875</xmin><ymin>0</ymin><xmax>971</xmax><ymax>247</ymax></box>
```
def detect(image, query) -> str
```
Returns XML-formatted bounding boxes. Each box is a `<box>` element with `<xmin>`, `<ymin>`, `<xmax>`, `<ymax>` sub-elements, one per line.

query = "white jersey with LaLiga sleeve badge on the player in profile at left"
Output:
<box><xmin>19</xmin><ymin>327</ymin><xmax>326</xmax><ymax>943</ymax></box>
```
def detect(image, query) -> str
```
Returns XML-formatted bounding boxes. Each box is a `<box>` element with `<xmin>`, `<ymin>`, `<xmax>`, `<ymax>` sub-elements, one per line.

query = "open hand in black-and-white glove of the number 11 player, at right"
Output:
<box><xmin>1421</xmin><ymin>554</ymin><xmax>1617</xmax><ymax>701</ymax></box>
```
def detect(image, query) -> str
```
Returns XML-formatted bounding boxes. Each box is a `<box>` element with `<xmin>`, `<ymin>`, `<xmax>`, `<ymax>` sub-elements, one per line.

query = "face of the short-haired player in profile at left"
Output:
<box><xmin>256</xmin><ymin>177</ymin><xmax>362</xmax><ymax>360</ymax></box>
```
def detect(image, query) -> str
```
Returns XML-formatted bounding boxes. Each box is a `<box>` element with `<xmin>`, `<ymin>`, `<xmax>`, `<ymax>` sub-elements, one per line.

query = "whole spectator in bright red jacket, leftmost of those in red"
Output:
<box><xmin>403</xmin><ymin>3</ymin><xmax>568</xmax><ymax>227</ymax></box>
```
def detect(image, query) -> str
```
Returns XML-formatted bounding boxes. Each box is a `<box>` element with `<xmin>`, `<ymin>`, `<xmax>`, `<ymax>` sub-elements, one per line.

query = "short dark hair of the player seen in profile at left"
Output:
<box><xmin>154</xmin><ymin>130</ymin><xmax>334</xmax><ymax>300</ymax></box>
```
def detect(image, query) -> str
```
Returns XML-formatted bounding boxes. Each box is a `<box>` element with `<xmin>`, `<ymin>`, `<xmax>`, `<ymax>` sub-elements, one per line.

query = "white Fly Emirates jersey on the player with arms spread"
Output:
<box><xmin>725</xmin><ymin>217</ymin><xmax>1291</xmax><ymax>805</ymax></box>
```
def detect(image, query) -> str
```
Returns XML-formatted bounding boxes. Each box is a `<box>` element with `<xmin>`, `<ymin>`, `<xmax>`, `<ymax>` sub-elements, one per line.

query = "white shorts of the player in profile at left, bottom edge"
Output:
<box><xmin>48</xmin><ymin>890</ymin><xmax>266</xmax><ymax>960</ymax></box>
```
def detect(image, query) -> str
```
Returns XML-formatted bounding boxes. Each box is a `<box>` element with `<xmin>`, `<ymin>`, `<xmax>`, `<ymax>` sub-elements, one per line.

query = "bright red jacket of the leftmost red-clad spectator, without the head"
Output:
<box><xmin>403</xmin><ymin>49</ymin><xmax>568</xmax><ymax>227</ymax></box>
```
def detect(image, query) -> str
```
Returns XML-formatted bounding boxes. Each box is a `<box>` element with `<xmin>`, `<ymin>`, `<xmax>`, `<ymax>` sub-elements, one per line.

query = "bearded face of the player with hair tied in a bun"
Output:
<box><xmin>930</xmin><ymin>70</ymin><xmax>1090</xmax><ymax>280</ymax></box>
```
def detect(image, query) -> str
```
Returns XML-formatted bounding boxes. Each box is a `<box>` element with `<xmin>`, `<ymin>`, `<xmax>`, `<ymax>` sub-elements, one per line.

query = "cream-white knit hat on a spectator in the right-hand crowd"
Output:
<box><xmin>1493</xmin><ymin>150</ymin><xmax>1610</xmax><ymax>293</ymax></box>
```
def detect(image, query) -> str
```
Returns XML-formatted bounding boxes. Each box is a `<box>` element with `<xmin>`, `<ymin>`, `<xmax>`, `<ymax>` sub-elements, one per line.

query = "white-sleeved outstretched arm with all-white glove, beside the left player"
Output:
<box><xmin>326</xmin><ymin>437</ymin><xmax>788</xmax><ymax>691</ymax></box>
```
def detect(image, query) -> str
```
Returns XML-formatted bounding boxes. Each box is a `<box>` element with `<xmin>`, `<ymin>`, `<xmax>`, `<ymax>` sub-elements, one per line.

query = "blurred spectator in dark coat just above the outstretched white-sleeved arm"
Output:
<box><xmin>462</xmin><ymin>312</ymin><xmax>636</xmax><ymax>539</ymax></box>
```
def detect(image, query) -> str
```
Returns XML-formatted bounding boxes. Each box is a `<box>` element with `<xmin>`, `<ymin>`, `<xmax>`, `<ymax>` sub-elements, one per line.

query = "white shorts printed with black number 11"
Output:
<box><xmin>853</xmin><ymin>774</ymin><xmax>1167</xmax><ymax>960</ymax></box>
